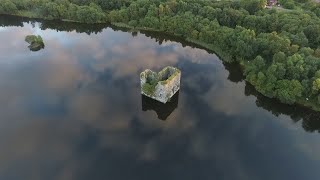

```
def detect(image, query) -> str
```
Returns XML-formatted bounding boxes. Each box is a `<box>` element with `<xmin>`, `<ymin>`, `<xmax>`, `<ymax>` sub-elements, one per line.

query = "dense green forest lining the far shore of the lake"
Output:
<box><xmin>0</xmin><ymin>0</ymin><xmax>320</xmax><ymax>111</ymax></box>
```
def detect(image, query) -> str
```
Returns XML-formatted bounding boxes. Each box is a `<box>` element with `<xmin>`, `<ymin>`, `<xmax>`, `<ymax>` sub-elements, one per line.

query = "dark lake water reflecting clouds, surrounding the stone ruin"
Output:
<box><xmin>0</xmin><ymin>16</ymin><xmax>320</xmax><ymax>180</ymax></box>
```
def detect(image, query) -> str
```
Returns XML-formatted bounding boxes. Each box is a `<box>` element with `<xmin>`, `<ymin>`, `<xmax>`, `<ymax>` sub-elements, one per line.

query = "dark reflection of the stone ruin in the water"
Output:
<box><xmin>141</xmin><ymin>91</ymin><xmax>179</xmax><ymax>121</ymax></box>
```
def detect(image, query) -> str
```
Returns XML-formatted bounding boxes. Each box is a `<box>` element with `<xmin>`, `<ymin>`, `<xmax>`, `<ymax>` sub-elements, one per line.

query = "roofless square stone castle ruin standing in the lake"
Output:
<box><xmin>140</xmin><ymin>66</ymin><xmax>181</xmax><ymax>103</ymax></box>
